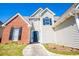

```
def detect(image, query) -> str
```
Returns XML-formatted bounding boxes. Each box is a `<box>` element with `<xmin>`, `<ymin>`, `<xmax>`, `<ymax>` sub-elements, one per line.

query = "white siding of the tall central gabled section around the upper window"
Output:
<box><xmin>40</xmin><ymin>12</ymin><xmax>55</xmax><ymax>43</ymax></box>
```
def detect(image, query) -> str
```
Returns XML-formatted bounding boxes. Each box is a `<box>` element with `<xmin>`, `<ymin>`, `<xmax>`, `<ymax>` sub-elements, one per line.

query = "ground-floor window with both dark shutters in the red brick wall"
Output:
<box><xmin>10</xmin><ymin>28</ymin><xmax>22</xmax><ymax>41</ymax></box>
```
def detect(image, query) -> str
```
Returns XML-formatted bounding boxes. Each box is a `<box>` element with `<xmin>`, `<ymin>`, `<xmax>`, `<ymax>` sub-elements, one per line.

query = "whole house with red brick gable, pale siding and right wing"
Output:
<box><xmin>1</xmin><ymin>4</ymin><xmax>79</xmax><ymax>48</ymax></box>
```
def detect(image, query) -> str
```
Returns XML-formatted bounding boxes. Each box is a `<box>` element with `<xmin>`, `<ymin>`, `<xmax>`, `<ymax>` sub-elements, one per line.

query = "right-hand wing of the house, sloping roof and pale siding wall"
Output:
<box><xmin>53</xmin><ymin>4</ymin><xmax>79</xmax><ymax>48</ymax></box>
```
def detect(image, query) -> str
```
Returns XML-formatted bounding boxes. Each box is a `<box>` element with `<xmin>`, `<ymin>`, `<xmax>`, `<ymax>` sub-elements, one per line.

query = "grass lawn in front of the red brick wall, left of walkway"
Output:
<box><xmin>0</xmin><ymin>43</ymin><xmax>26</xmax><ymax>56</ymax></box>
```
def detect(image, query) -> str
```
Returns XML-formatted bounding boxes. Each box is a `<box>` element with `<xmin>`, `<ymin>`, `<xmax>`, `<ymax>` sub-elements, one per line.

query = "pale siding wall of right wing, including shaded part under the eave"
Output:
<box><xmin>55</xmin><ymin>17</ymin><xmax>79</xmax><ymax>48</ymax></box>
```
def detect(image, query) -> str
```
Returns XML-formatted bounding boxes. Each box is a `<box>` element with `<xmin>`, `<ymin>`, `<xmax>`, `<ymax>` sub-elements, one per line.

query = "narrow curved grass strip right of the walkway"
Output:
<box><xmin>44</xmin><ymin>44</ymin><xmax>79</xmax><ymax>56</ymax></box>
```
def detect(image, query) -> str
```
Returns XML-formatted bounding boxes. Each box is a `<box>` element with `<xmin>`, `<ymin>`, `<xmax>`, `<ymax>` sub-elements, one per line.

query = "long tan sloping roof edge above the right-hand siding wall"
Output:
<box><xmin>53</xmin><ymin>3</ymin><xmax>77</xmax><ymax>28</ymax></box>
